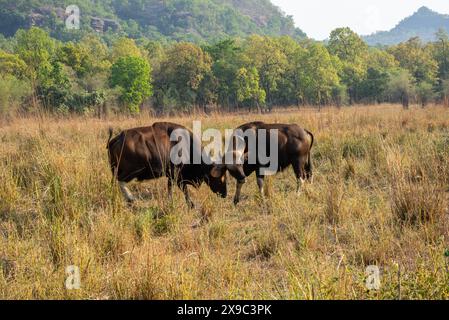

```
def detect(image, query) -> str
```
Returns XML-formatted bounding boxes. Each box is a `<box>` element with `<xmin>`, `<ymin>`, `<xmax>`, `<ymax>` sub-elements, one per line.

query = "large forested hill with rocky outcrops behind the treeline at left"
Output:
<box><xmin>0</xmin><ymin>0</ymin><xmax>305</xmax><ymax>42</ymax></box>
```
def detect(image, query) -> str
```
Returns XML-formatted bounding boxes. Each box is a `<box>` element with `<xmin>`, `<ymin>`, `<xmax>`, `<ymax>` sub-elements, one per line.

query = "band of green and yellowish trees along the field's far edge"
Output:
<box><xmin>0</xmin><ymin>27</ymin><xmax>449</xmax><ymax>115</ymax></box>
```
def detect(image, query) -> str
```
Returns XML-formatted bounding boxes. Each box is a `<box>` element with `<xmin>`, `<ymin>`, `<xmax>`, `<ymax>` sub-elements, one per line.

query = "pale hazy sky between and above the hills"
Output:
<box><xmin>272</xmin><ymin>0</ymin><xmax>449</xmax><ymax>40</ymax></box>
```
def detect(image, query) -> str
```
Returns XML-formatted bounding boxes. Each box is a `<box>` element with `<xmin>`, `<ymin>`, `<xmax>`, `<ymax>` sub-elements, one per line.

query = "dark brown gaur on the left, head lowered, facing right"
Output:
<box><xmin>107</xmin><ymin>122</ymin><xmax>227</xmax><ymax>208</ymax></box>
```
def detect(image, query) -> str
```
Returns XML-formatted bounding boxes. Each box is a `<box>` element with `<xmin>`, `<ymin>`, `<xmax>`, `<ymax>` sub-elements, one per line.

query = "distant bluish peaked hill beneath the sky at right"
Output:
<box><xmin>364</xmin><ymin>7</ymin><xmax>449</xmax><ymax>45</ymax></box>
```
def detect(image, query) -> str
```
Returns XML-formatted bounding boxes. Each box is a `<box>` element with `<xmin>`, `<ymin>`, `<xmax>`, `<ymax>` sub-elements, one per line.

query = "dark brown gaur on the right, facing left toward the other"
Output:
<box><xmin>219</xmin><ymin>122</ymin><xmax>314</xmax><ymax>205</ymax></box>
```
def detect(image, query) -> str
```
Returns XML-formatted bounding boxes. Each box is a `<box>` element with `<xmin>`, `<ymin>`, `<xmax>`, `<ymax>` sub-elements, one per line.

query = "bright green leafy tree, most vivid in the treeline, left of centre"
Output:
<box><xmin>110</xmin><ymin>56</ymin><xmax>152</xmax><ymax>113</ymax></box>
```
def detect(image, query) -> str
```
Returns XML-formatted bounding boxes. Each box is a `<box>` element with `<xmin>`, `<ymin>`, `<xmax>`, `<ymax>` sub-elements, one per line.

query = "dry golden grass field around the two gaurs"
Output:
<box><xmin>0</xmin><ymin>105</ymin><xmax>449</xmax><ymax>299</ymax></box>
